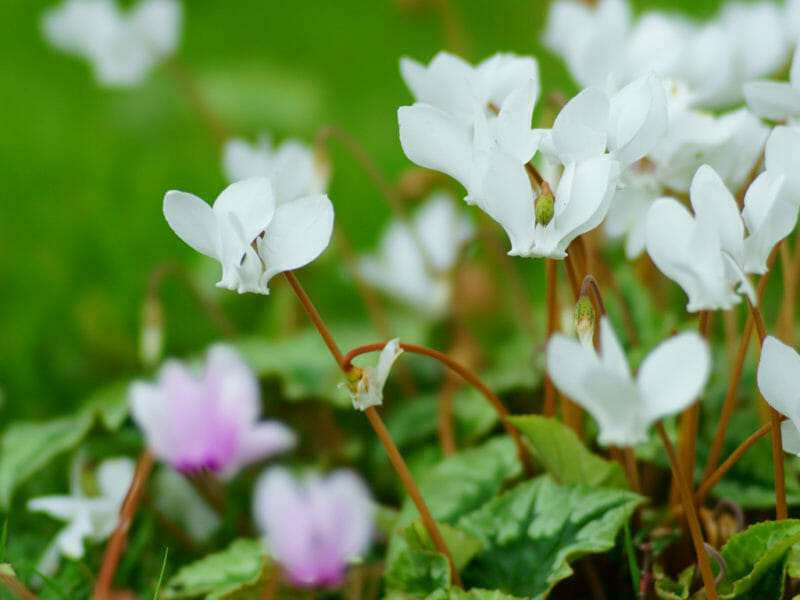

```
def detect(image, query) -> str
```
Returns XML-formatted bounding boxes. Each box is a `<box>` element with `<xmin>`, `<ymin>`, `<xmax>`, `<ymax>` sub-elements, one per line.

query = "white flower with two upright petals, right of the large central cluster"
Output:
<box><xmin>646</xmin><ymin>165</ymin><xmax>756</xmax><ymax>312</ymax></box>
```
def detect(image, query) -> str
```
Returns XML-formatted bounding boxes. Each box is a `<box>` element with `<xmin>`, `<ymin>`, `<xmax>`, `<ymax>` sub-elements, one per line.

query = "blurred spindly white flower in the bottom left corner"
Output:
<box><xmin>28</xmin><ymin>458</ymin><xmax>135</xmax><ymax>575</ymax></box>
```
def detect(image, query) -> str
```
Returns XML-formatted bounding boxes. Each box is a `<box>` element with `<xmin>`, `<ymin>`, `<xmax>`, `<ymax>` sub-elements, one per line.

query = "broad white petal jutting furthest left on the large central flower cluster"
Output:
<box><xmin>397</xmin><ymin>104</ymin><xmax>472</xmax><ymax>187</ymax></box>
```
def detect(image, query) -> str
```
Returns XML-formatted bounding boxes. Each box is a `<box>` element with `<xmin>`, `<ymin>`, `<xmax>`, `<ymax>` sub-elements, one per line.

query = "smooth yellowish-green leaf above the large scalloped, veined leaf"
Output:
<box><xmin>508</xmin><ymin>415</ymin><xmax>628</xmax><ymax>489</ymax></box>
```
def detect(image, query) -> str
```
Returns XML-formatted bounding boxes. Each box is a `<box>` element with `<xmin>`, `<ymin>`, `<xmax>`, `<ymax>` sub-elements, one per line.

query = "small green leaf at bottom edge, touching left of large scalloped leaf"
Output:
<box><xmin>385</xmin><ymin>550</ymin><xmax>450</xmax><ymax>597</ymax></box>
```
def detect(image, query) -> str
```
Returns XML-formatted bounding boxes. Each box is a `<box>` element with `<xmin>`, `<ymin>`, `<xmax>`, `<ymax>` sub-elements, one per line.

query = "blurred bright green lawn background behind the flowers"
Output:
<box><xmin>0</xmin><ymin>0</ymin><xmax>736</xmax><ymax>425</ymax></box>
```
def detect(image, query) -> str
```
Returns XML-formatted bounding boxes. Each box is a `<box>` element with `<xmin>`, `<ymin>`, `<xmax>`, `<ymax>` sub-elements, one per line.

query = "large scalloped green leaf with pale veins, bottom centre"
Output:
<box><xmin>458</xmin><ymin>476</ymin><xmax>643</xmax><ymax>598</ymax></box>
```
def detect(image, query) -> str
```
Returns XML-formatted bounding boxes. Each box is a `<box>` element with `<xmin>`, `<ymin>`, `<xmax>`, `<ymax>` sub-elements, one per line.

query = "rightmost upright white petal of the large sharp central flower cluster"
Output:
<box><xmin>608</xmin><ymin>75</ymin><xmax>667</xmax><ymax>169</ymax></box>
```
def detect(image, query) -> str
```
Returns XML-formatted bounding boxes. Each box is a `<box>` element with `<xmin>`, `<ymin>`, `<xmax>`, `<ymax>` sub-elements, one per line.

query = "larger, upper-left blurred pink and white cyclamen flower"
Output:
<box><xmin>130</xmin><ymin>345</ymin><xmax>295</xmax><ymax>476</ymax></box>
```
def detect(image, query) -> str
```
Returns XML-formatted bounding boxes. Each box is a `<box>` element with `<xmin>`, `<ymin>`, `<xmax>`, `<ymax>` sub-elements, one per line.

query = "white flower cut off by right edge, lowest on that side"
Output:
<box><xmin>756</xmin><ymin>335</ymin><xmax>800</xmax><ymax>456</ymax></box>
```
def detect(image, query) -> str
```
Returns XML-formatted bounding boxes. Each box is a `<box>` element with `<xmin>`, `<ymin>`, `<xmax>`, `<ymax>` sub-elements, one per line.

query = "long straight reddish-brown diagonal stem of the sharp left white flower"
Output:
<box><xmin>284</xmin><ymin>271</ymin><xmax>461</xmax><ymax>584</ymax></box>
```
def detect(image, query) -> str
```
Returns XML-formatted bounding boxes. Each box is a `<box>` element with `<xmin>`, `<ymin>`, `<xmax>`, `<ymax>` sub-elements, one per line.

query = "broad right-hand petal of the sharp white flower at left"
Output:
<box><xmin>258</xmin><ymin>194</ymin><xmax>333</xmax><ymax>285</ymax></box>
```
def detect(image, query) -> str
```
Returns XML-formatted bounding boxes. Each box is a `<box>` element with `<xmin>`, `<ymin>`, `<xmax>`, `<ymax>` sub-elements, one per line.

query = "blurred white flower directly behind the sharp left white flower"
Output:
<box><xmin>222</xmin><ymin>133</ymin><xmax>328</xmax><ymax>205</ymax></box>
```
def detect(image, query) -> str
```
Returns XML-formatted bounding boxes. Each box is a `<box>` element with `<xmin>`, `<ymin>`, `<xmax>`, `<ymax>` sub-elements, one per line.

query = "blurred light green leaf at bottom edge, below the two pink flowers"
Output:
<box><xmin>162</xmin><ymin>538</ymin><xmax>266</xmax><ymax>600</ymax></box>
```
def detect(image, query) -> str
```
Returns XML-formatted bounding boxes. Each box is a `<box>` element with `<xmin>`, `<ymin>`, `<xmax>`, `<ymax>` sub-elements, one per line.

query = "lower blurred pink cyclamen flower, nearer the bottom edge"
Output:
<box><xmin>253</xmin><ymin>467</ymin><xmax>373</xmax><ymax>587</ymax></box>
